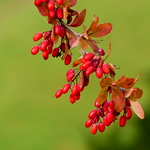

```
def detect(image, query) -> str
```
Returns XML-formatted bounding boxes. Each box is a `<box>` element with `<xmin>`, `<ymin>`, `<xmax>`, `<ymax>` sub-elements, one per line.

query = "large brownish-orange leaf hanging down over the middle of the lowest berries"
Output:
<box><xmin>111</xmin><ymin>87</ymin><xmax>125</xmax><ymax>112</ymax></box>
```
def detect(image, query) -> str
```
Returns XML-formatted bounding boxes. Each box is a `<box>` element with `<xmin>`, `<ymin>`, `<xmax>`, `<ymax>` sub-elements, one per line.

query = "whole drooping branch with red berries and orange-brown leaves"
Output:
<box><xmin>31</xmin><ymin>0</ymin><xmax>144</xmax><ymax>134</ymax></box>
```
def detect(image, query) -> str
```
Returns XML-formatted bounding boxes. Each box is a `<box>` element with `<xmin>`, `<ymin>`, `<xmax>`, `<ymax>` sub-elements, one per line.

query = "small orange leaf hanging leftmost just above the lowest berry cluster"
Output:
<box><xmin>98</xmin><ymin>89</ymin><xmax>108</xmax><ymax>105</ymax></box>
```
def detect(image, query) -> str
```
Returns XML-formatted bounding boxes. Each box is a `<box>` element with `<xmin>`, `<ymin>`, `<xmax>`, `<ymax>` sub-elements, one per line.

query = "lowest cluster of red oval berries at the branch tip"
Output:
<box><xmin>85</xmin><ymin>99</ymin><xmax>132</xmax><ymax>134</ymax></box>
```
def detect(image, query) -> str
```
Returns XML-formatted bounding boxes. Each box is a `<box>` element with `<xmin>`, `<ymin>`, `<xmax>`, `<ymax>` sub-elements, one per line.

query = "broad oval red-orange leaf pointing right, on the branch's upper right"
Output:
<box><xmin>88</xmin><ymin>23</ymin><xmax>112</xmax><ymax>37</ymax></box>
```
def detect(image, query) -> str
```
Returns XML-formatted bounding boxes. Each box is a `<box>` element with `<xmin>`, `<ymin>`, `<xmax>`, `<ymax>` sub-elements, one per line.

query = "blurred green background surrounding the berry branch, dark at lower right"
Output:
<box><xmin>0</xmin><ymin>0</ymin><xmax>150</xmax><ymax>150</ymax></box>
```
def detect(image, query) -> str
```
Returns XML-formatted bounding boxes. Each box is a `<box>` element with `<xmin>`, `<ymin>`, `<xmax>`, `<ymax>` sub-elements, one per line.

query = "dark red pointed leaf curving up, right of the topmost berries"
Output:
<box><xmin>70</xmin><ymin>9</ymin><xmax>86</xmax><ymax>27</ymax></box>
